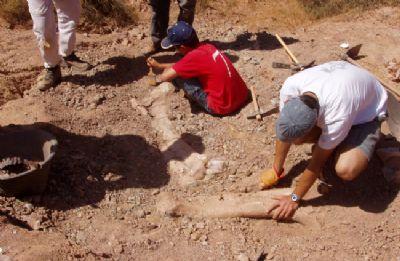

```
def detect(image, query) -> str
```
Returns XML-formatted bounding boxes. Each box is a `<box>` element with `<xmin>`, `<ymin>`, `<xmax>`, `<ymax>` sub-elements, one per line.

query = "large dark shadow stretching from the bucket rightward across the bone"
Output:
<box><xmin>6</xmin><ymin>123</ymin><xmax>204</xmax><ymax>210</ymax></box>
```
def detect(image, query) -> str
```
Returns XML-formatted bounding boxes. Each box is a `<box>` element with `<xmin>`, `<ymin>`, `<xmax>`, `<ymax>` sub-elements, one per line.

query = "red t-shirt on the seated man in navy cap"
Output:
<box><xmin>172</xmin><ymin>43</ymin><xmax>248</xmax><ymax>115</ymax></box>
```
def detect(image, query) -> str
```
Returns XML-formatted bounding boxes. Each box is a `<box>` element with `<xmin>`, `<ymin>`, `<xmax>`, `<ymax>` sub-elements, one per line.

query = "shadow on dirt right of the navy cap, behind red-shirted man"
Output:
<box><xmin>207</xmin><ymin>31</ymin><xmax>299</xmax><ymax>51</ymax></box>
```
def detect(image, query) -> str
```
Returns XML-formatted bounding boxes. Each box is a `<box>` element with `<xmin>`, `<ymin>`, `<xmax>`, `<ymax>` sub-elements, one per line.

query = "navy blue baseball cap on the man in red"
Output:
<box><xmin>161</xmin><ymin>21</ymin><xmax>195</xmax><ymax>49</ymax></box>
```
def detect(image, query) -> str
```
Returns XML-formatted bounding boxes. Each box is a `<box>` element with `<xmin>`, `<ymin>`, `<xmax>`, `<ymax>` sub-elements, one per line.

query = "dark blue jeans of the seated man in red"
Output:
<box><xmin>172</xmin><ymin>78</ymin><xmax>214</xmax><ymax>114</ymax></box>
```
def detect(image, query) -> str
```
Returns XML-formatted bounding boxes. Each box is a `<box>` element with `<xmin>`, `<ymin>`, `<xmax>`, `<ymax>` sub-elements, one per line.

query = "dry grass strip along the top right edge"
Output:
<box><xmin>198</xmin><ymin>0</ymin><xmax>400</xmax><ymax>29</ymax></box>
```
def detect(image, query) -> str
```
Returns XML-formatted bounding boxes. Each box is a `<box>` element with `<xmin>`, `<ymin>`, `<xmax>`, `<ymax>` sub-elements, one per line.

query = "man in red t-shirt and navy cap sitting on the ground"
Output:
<box><xmin>147</xmin><ymin>21</ymin><xmax>249</xmax><ymax>115</ymax></box>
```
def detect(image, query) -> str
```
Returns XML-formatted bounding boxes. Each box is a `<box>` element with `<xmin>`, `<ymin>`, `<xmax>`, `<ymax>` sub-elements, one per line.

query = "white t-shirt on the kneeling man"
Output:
<box><xmin>280</xmin><ymin>61</ymin><xmax>387</xmax><ymax>149</ymax></box>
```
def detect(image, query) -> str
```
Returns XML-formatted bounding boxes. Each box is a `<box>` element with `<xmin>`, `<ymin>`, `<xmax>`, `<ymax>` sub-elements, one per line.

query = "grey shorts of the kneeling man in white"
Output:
<box><xmin>337</xmin><ymin>119</ymin><xmax>382</xmax><ymax>161</ymax></box>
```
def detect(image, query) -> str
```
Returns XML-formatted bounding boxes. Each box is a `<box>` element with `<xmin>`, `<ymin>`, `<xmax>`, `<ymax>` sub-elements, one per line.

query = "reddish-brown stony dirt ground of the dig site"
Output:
<box><xmin>0</xmin><ymin>3</ymin><xmax>400</xmax><ymax>260</ymax></box>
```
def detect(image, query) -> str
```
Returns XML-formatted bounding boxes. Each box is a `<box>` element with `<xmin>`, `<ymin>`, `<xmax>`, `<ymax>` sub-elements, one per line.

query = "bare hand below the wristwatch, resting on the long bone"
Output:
<box><xmin>267</xmin><ymin>196</ymin><xmax>299</xmax><ymax>220</ymax></box>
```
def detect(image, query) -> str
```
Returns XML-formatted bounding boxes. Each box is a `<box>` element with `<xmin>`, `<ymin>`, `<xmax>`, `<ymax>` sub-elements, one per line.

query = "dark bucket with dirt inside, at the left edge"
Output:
<box><xmin>0</xmin><ymin>125</ymin><xmax>58</xmax><ymax>196</ymax></box>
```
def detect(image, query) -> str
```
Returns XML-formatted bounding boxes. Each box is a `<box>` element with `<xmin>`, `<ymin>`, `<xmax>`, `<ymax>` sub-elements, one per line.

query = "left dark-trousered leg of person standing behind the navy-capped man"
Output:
<box><xmin>150</xmin><ymin>0</ymin><xmax>170</xmax><ymax>52</ymax></box>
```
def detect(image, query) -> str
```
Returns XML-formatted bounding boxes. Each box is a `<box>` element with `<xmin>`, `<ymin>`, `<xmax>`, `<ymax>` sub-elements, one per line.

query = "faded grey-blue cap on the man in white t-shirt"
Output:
<box><xmin>275</xmin><ymin>97</ymin><xmax>318</xmax><ymax>142</ymax></box>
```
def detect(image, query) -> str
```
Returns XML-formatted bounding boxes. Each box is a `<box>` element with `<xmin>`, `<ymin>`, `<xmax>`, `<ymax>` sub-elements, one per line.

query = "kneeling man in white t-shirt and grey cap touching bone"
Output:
<box><xmin>261</xmin><ymin>61</ymin><xmax>387</xmax><ymax>220</ymax></box>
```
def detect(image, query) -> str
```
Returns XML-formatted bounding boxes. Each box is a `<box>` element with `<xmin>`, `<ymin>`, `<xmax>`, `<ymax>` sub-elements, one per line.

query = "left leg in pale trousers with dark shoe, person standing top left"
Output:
<box><xmin>28</xmin><ymin>0</ymin><xmax>61</xmax><ymax>91</ymax></box>
